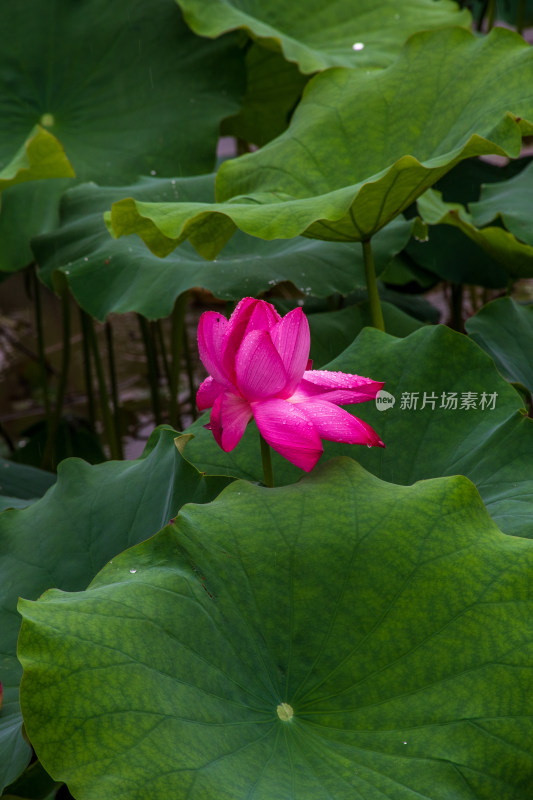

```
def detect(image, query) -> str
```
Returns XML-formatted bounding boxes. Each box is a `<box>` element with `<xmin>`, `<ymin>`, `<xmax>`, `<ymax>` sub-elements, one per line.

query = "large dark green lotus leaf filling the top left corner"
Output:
<box><xmin>0</xmin><ymin>0</ymin><xmax>244</xmax><ymax>270</ymax></box>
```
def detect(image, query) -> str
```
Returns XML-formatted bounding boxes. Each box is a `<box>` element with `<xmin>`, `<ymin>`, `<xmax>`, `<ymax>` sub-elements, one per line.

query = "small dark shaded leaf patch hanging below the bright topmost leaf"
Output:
<box><xmin>221</xmin><ymin>44</ymin><xmax>308</xmax><ymax>147</ymax></box>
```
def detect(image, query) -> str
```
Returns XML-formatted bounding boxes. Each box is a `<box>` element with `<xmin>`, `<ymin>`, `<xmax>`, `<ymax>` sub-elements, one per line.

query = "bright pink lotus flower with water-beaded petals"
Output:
<box><xmin>196</xmin><ymin>297</ymin><xmax>385</xmax><ymax>472</ymax></box>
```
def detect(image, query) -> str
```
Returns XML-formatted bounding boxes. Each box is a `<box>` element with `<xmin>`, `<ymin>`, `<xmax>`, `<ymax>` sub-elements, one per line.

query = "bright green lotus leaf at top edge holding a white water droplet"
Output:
<box><xmin>177</xmin><ymin>0</ymin><xmax>471</xmax><ymax>73</ymax></box>
